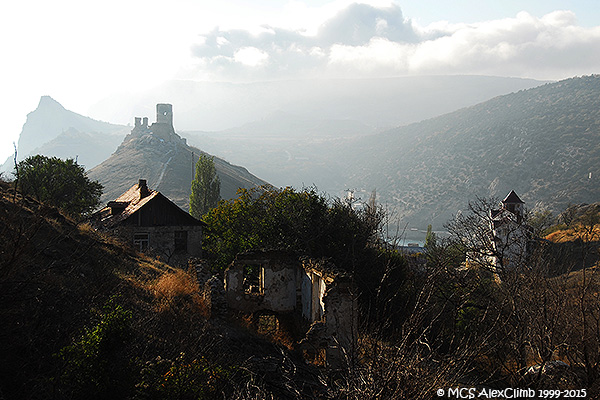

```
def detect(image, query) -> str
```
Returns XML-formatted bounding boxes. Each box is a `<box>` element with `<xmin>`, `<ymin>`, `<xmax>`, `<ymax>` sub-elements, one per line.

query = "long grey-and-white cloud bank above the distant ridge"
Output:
<box><xmin>192</xmin><ymin>4</ymin><xmax>600</xmax><ymax>80</ymax></box>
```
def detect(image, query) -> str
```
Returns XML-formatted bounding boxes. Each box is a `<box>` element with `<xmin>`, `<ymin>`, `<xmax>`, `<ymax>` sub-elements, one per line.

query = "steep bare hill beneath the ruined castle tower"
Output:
<box><xmin>88</xmin><ymin>106</ymin><xmax>266</xmax><ymax>210</ymax></box>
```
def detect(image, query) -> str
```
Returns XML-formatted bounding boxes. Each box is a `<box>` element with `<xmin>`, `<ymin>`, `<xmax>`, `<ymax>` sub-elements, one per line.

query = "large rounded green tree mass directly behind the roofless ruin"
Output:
<box><xmin>203</xmin><ymin>187</ymin><xmax>380</xmax><ymax>271</ymax></box>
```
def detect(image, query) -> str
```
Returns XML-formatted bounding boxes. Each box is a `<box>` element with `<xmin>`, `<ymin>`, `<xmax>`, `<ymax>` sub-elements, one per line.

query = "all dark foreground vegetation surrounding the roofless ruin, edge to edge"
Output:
<box><xmin>0</xmin><ymin>176</ymin><xmax>600</xmax><ymax>399</ymax></box>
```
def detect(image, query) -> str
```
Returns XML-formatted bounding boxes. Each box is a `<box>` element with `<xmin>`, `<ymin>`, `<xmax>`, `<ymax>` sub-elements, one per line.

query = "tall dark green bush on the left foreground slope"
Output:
<box><xmin>58</xmin><ymin>298</ymin><xmax>135</xmax><ymax>399</ymax></box>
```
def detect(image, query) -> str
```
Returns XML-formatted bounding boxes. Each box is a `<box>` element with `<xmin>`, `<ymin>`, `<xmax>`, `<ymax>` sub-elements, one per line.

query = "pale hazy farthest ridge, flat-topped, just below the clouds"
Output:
<box><xmin>90</xmin><ymin>76</ymin><xmax>545</xmax><ymax>131</ymax></box>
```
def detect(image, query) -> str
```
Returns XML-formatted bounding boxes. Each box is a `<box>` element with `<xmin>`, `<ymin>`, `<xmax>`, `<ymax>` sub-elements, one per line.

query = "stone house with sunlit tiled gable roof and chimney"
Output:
<box><xmin>91</xmin><ymin>179</ymin><xmax>206</xmax><ymax>264</ymax></box>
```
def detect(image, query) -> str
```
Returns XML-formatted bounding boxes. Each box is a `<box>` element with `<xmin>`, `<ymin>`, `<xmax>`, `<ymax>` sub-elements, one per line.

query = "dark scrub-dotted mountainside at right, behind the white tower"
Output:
<box><xmin>339</xmin><ymin>75</ymin><xmax>600</xmax><ymax>226</ymax></box>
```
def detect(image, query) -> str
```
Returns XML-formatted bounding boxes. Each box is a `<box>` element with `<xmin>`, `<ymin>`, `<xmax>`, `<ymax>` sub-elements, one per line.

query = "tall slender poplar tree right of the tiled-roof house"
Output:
<box><xmin>190</xmin><ymin>154</ymin><xmax>221</xmax><ymax>219</ymax></box>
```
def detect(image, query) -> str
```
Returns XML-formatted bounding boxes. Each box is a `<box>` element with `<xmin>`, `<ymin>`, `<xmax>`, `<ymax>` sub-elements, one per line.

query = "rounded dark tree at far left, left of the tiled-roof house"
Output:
<box><xmin>17</xmin><ymin>155</ymin><xmax>103</xmax><ymax>217</ymax></box>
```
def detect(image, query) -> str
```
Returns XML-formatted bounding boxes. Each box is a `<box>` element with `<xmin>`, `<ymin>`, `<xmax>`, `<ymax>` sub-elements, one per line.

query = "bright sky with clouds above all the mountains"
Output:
<box><xmin>0</xmin><ymin>0</ymin><xmax>600</xmax><ymax>162</ymax></box>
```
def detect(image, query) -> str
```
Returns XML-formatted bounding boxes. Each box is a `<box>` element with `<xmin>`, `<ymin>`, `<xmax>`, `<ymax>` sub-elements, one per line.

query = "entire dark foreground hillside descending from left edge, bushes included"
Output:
<box><xmin>0</xmin><ymin>180</ymin><xmax>322</xmax><ymax>399</ymax></box>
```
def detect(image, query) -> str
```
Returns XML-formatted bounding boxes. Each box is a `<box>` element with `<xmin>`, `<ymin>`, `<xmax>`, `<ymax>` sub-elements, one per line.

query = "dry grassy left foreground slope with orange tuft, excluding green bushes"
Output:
<box><xmin>0</xmin><ymin>183</ymin><xmax>314</xmax><ymax>398</ymax></box>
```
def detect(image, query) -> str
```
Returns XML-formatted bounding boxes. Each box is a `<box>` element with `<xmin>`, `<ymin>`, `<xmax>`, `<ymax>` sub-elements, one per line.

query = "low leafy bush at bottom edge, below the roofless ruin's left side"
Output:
<box><xmin>135</xmin><ymin>353</ymin><xmax>231</xmax><ymax>400</ymax></box>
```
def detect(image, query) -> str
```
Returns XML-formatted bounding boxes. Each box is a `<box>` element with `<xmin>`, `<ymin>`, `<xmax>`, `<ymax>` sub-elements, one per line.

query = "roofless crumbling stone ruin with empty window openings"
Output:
<box><xmin>225</xmin><ymin>251</ymin><xmax>358</xmax><ymax>368</ymax></box>
